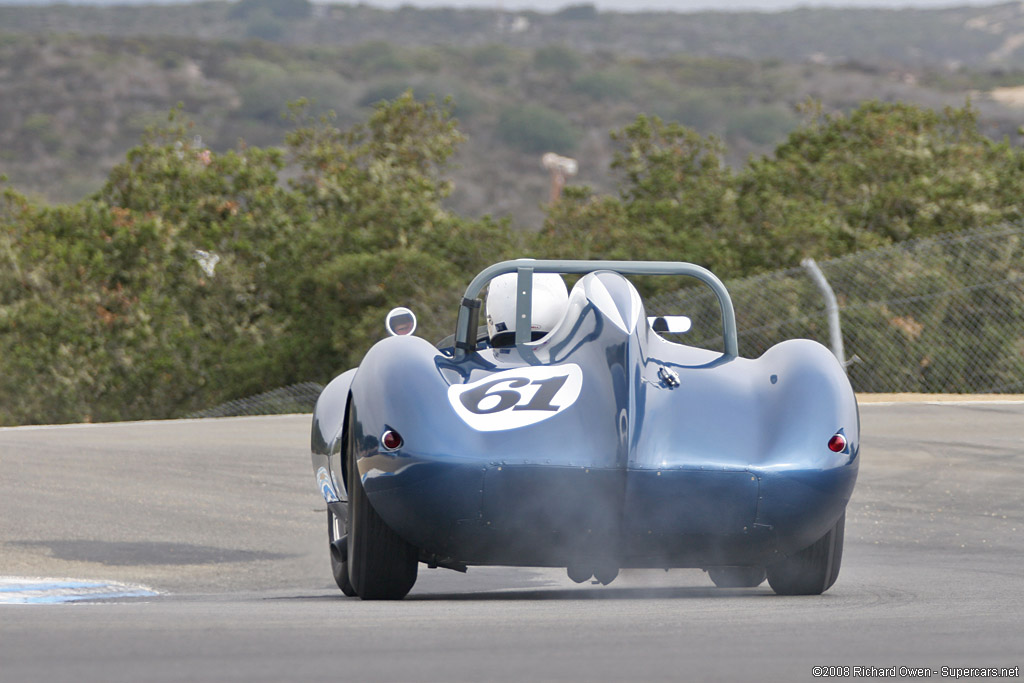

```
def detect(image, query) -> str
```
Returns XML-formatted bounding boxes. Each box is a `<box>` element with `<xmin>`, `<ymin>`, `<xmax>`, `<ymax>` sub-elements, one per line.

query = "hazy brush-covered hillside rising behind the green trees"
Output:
<box><xmin>6</xmin><ymin>0</ymin><xmax>1024</xmax><ymax>226</ymax></box>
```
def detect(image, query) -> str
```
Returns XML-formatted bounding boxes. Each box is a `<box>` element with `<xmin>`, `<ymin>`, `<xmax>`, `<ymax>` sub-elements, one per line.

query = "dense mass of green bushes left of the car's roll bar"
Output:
<box><xmin>0</xmin><ymin>95</ymin><xmax>516</xmax><ymax>424</ymax></box>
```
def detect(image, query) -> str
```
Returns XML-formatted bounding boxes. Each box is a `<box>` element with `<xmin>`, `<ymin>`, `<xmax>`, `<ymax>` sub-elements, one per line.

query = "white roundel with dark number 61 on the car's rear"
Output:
<box><xmin>449</xmin><ymin>364</ymin><xmax>583</xmax><ymax>431</ymax></box>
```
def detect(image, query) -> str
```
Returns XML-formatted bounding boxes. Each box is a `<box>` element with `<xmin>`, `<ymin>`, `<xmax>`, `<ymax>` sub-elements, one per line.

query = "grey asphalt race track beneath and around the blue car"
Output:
<box><xmin>0</xmin><ymin>403</ymin><xmax>1024</xmax><ymax>682</ymax></box>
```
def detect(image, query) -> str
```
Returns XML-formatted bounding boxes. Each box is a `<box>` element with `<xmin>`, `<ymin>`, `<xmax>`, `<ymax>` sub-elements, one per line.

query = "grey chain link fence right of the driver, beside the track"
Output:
<box><xmin>647</xmin><ymin>225</ymin><xmax>1024</xmax><ymax>393</ymax></box>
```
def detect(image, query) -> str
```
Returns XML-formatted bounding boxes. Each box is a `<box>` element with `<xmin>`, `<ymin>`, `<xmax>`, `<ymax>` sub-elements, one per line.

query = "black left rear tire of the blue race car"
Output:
<box><xmin>348</xmin><ymin>419</ymin><xmax>420</xmax><ymax>600</ymax></box>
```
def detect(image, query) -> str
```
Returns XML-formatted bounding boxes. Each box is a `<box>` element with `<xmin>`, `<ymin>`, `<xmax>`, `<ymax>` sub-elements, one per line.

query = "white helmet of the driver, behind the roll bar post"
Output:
<box><xmin>484</xmin><ymin>272</ymin><xmax>569</xmax><ymax>346</ymax></box>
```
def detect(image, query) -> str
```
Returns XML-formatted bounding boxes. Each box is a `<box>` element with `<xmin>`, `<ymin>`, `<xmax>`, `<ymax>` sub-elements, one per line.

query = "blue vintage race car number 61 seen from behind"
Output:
<box><xmin>312</xmin><ymin>259</ymin><xmax>860</xmax><ymax>599</ymax></box>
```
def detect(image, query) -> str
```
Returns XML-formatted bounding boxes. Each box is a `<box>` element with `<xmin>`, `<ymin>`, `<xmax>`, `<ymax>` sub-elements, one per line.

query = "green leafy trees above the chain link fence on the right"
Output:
<box><xmin>544</xmin><ymin>102</ymin><xmax>1024</xmax><ymax>286</ymax></box>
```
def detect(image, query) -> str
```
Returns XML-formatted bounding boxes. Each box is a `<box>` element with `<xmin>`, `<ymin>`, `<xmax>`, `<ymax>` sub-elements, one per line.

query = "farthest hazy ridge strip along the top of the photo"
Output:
<box><xmin>0</xmin><ymin>0</ymin><xmax>1024</xmax><ymax>67</ymax></box>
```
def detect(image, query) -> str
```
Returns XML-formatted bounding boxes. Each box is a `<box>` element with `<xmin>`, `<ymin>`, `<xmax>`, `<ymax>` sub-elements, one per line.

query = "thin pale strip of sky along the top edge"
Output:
<box><xmin>361</xmin><ymin>0</ymin><xmax>999</xmax><ymax>11</ymax></box>
